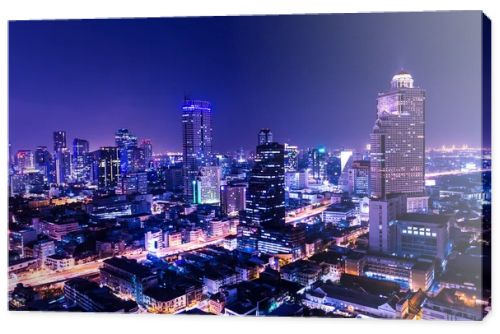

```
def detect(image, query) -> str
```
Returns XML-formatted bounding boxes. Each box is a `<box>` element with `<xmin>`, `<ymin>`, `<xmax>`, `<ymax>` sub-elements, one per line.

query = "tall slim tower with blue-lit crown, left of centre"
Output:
<box><xmin>182</xmin><ymin>100</ymin><xmax>212</xmax><ymax>202</ymax></box>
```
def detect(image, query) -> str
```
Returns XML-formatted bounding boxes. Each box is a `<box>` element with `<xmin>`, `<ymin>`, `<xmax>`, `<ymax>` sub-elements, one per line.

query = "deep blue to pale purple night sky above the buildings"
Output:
<box><xmin>9</xmin><ymin>11</ymin><xmax>481</xmax><ymax>152</ymax></box>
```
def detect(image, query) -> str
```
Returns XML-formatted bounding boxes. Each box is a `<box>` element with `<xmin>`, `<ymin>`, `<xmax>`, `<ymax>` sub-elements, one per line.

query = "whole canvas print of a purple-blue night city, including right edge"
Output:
<box><xmin>8</xmin><ymin>11</ymin><xmax>491</xmax><ymax>321</ymax></box>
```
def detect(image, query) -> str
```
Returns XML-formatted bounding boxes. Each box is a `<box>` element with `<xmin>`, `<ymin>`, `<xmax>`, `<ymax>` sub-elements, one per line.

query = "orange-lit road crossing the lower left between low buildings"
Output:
<box><xmin>9</xmin><ymin>236</ymin><xmax>230</xmax><ymax>291</ymax></box>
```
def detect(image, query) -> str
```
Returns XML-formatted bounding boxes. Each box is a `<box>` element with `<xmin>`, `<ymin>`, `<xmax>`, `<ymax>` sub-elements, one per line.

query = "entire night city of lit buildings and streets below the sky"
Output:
<box><xmin>8</xmin><ymin>13</ymin><xmax>491</xmax><ymax>320</ymax></box>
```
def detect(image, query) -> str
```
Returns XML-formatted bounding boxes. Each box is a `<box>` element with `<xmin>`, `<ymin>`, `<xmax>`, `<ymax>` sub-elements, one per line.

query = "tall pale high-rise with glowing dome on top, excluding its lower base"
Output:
<box><xmin>370</xmin><ymin>71</ymin><xmax>425</xmax><ymax>198</ymax></box>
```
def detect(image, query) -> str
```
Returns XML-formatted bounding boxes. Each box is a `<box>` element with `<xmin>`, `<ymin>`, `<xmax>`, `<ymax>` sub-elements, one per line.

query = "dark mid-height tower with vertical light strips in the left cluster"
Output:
<box><xmin>94</xmin><ymin>146</ymin><xmax>120</xmax><ymax>190</ymax></box>
